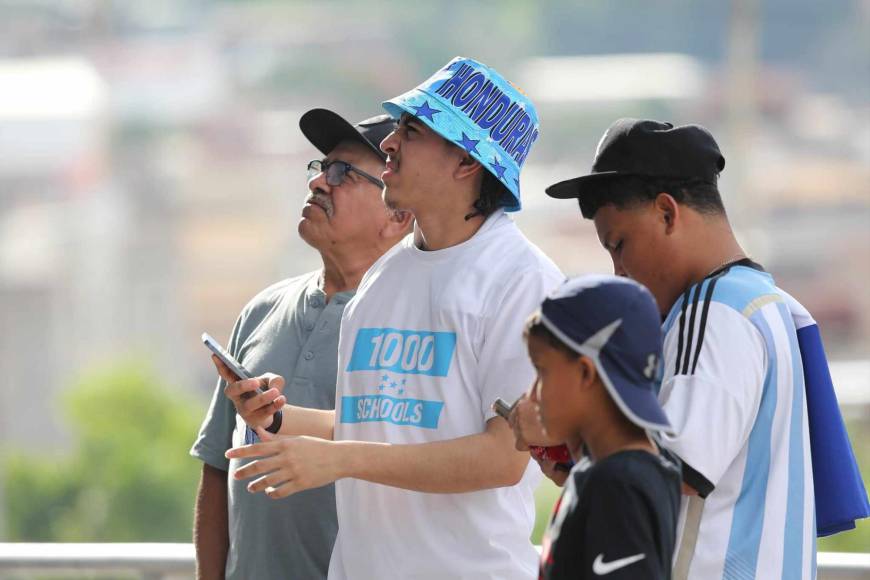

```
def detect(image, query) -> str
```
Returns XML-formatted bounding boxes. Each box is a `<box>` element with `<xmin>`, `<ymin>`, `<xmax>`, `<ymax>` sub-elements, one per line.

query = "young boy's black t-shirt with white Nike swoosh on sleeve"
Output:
<box><xmin>540</xmin><ymin>450</ymin><xmax>680</xmax><ymax>580</ymax></box>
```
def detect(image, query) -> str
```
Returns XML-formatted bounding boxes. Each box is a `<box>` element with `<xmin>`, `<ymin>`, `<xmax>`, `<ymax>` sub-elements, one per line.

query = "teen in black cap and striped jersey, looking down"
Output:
<box><xmin>547</xmin><ymin>119</ymin><xmax>816</xmax><ymax>580</ymax></box>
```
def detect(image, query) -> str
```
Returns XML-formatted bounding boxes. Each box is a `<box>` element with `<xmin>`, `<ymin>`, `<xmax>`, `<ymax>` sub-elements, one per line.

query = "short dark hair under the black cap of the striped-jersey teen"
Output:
<box><xmin>577</xmin><ymin>175</ymin><xmax>725</xmax><ymax>219</ymax></box>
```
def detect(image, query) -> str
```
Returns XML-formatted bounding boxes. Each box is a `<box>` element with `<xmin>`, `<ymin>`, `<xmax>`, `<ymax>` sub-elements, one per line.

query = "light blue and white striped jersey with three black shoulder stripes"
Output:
<box><xmin>659</xmin><ymin>260</ymin><xmax>816</xmax><ymax>580</ymax></box>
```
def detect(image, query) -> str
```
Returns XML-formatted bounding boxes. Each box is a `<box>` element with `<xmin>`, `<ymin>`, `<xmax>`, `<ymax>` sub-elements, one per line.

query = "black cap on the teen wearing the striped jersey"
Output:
<box><xmin>546</xmin><ymin>119</ymin><xmax>725</xmax><ymax>199</ymax></box>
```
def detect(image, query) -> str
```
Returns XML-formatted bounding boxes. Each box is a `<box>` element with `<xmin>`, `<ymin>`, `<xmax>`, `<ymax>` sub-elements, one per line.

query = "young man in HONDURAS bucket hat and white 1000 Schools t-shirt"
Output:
<box><xmin>229</xmin><ymin>58</ymin><xmax>564</xmax><ymax>580</ymax></box>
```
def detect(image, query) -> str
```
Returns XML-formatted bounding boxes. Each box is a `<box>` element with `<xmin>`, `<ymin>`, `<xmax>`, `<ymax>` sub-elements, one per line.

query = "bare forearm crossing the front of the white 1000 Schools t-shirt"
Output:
<box><xmin>336</xmin><ymin>418</ymin><xmax>529</xmax><ymax>493</ymax></box>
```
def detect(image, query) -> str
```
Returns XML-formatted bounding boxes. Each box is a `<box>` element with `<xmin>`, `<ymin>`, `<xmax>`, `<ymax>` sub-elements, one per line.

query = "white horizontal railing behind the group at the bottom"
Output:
<box><xmin>0</xmin><ymin>543</ymin><xmax>870</xmax><ymax>580</ymax></box>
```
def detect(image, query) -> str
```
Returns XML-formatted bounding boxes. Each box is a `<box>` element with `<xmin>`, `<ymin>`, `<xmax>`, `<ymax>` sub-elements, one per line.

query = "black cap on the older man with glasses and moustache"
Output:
<box><xmin>299</xmin><ymin>109</ymin><xmax>396</xmax><ymax>160</ymax></box>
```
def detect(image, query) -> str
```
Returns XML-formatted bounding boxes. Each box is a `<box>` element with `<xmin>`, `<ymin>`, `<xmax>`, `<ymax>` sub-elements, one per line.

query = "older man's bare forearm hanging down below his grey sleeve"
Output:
<box><xmin>193</xmin><ymin>463</ymin><xmax>229</xmax><ymax>580</ymax></box>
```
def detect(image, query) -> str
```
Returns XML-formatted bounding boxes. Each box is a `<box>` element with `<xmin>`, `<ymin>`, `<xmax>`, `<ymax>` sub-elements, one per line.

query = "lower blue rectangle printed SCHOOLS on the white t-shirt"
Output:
<box><xmin>341</xmin><ymin>395</ymin><xmax>444</xmax><ymax>429</ymax></box>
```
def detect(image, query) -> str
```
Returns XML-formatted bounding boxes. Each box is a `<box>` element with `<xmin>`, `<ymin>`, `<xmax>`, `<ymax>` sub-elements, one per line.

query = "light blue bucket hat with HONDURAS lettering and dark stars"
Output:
<box><xmin>384</xmin><ymin>56</ymin><xmax>539</xmax><ymax>211</ymax></box>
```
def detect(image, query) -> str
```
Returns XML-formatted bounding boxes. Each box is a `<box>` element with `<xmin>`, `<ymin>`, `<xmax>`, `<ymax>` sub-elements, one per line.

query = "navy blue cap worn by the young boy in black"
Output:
<box><xmin>540</xmin><ymin>275</ymin><xmax>671</xmax><ymax>432</ymax></box>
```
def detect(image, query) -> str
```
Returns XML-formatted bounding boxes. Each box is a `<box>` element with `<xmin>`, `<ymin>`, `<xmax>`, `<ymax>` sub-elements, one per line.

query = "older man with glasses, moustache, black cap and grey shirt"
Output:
<box><xmin>191</xmin><ymin>109</ymin><xmax>411</xmax><ymax>579</ymax></box>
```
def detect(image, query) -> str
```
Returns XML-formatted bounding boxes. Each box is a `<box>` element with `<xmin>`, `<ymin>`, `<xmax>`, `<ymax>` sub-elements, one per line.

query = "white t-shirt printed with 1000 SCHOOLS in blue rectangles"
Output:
<box><xmin>329</xmin><ymin>211</ymin><xmax>564</xmax><ymax>580</ymax></box>
